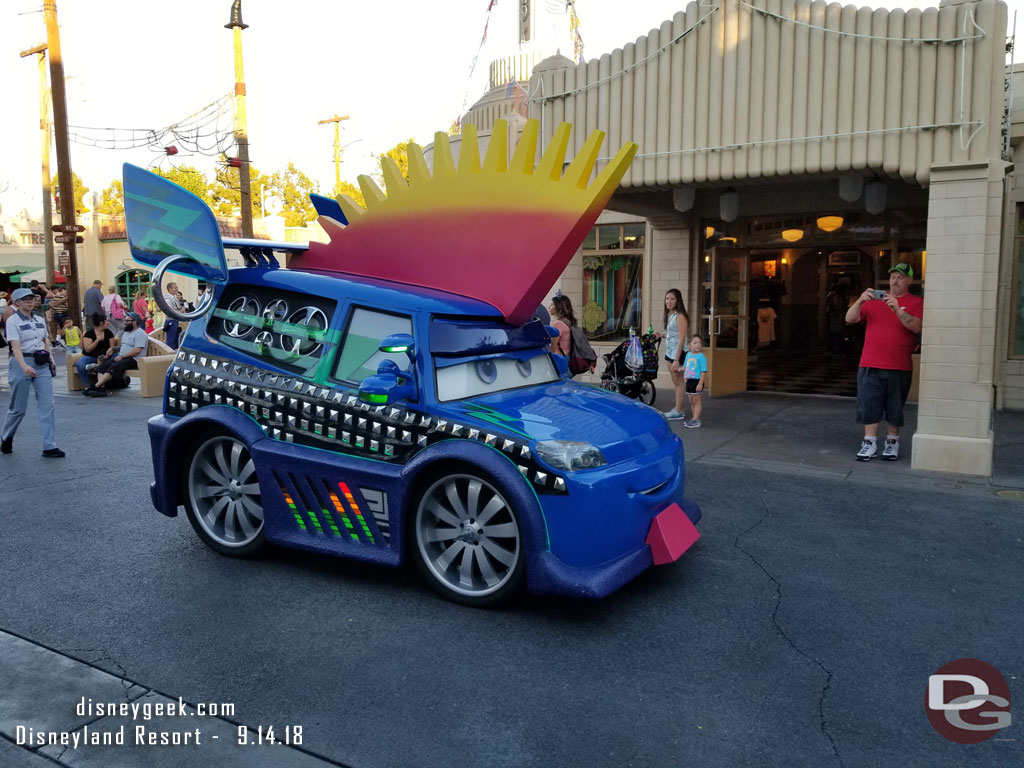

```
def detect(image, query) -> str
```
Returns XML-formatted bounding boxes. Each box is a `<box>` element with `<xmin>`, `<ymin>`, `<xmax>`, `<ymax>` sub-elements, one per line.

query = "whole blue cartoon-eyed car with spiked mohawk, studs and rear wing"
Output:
<box><xmin>124</xmin><ymin>117</ymin><xmax>700</xmax><ymax>606</ymax></box>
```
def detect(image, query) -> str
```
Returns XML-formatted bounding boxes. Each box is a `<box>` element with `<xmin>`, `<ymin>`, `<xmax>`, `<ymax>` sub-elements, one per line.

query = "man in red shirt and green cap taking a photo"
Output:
<box><xmin>846</xmin><ymin>261</ymin><xmax>925</xmax><ymax>462</ymax></box>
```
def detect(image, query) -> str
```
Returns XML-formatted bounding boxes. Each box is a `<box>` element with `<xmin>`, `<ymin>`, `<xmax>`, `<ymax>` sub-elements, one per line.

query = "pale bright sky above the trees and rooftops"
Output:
<box><xmin>0</xmin><ymin>0</ymin><xmax>1011</xmax><ymax>215</ymax></box>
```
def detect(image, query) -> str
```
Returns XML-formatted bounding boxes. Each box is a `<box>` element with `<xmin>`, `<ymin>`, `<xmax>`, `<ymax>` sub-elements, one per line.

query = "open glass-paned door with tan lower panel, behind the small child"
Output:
<box><xmin>700</xmin><ymin>248</ymin><xmax>751</xmax><ymax>395</ymax></box>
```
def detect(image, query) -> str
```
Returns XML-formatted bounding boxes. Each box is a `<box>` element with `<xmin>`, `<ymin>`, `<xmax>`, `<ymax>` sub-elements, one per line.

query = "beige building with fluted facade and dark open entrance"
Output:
<box><xmin>464</xmin><ymin>0</ymin><xmax>1024</xmax><ymax>475</ymax></box>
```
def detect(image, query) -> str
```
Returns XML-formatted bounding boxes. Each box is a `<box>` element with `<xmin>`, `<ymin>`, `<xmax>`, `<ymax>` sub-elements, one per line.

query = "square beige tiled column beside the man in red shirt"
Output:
<box><xmin>910</xmin><ymin>160</ymin><xmax>1009</xmax><ymax>476</ymax></box>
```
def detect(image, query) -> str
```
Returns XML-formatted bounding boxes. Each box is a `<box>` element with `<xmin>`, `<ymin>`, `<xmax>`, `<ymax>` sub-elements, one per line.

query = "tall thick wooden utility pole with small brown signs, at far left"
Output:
<box><xmin>43</xmin><ymin>0</ymin><xmax>82</xmax><ymax>321</ymax></box>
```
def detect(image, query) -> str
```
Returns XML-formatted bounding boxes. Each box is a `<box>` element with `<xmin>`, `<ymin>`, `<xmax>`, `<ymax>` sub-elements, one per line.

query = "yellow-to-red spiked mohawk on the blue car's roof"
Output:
<box><xmin>293</xmin><ymin>120</ymin><xmax>637</xmax><ymax>325</ymax></box>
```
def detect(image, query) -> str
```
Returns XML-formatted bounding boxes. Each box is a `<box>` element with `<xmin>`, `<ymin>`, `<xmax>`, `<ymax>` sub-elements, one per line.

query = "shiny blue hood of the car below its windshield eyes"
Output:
<box><xmin>438</xmin><ymin>381</ymin><xmax>678</xmax><ymax>463</ymax></box>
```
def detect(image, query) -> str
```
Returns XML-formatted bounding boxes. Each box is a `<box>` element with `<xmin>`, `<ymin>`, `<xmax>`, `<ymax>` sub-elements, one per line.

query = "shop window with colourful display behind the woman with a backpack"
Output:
<box><xmin>575</xmin><ymin>223</ymin><xmax>646</xmax><ymax>341</ymax></box>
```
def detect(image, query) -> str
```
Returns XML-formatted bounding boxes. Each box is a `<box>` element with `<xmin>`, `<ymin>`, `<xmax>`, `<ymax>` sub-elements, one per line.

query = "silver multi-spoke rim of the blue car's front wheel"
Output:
<box><xmin>416</xmin><ymin>475</ymin><xmax>522</xmax><ymax>597</ymax></box>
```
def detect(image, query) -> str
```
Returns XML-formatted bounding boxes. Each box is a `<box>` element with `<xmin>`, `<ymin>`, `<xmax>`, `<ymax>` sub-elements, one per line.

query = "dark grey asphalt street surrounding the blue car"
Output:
<box><xmin>0</xmin><ymin>356</ymin><xmax>1024</xmax><ymax>768</ymax></box>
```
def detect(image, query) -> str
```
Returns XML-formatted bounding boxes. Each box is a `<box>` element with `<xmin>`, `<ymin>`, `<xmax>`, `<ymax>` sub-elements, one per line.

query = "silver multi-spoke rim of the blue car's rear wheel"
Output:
<box><xmin>188</xmin><ymin>437</ymin><xmax>263</xmax><ymax>547</ymax></box>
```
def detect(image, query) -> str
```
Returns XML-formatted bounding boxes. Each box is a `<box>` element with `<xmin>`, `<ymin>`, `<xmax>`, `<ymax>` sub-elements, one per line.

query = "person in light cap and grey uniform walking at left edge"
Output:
<box><xmin>0</xmin><ymin>288</ymin><xmax>65</xmax><ymax>459</ymax></box>
